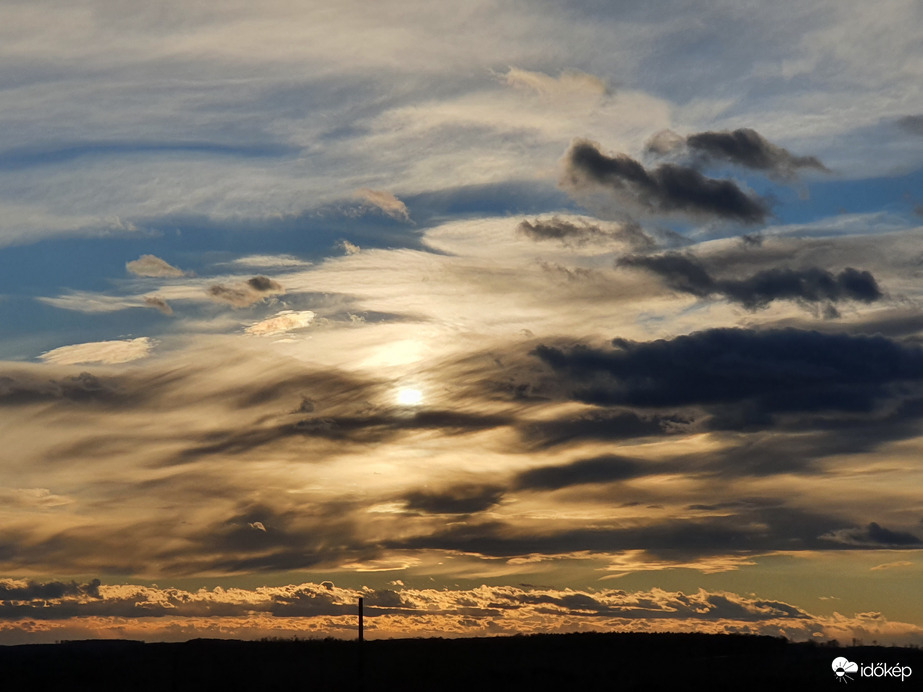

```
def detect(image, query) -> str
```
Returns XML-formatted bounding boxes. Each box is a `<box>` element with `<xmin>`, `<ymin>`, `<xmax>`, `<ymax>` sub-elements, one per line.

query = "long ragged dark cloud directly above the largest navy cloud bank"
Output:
<box><xmin>619</xmin><ymin>253</ymin><xmax>882</xmax><ymax>310</ymax></box>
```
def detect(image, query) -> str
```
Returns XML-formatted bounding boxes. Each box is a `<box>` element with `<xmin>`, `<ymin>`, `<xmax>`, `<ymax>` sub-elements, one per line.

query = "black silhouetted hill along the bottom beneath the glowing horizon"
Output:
<box><xmin>0</xmin><ymin>633</ymin><xmax>923</xmax><ymax>692</ymax></box>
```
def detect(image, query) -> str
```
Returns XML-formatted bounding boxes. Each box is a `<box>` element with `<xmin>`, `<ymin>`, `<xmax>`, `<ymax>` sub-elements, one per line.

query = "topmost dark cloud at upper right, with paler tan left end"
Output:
<box><xmin>646</xmin><ymin>128</ymin><xmax>829</xmax><ymax>179</ymax></box>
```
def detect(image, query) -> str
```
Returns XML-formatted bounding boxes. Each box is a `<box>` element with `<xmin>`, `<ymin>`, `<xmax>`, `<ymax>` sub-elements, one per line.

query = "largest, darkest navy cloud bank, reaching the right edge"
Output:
<box><xmin>532</xmin><ymin>329</ymin><xmax>923</xmax><ymax>415</ymax></box>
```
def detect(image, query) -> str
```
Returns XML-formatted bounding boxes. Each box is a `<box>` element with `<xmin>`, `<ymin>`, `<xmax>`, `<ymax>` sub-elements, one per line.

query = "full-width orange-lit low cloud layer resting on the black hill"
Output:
<box><xmin>0</xmin><ymin>580</ymin><xmax>923</xmax><ymax>642</ymax></box>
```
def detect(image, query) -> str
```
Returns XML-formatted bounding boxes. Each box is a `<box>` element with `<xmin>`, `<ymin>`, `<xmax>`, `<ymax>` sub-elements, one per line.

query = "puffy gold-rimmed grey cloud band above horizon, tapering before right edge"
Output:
<box><xmin>0</xmin><ymin>580</ymin><xmax>844</xmax><ymax>634</ymax></box>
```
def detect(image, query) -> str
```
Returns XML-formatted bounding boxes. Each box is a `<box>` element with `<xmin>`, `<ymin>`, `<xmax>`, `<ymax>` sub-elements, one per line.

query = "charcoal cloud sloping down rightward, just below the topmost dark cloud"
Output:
<box><xmin>565</xmin><ymin>140</ymin><xmax>769</xmax><ymax>223</ymax></box>
